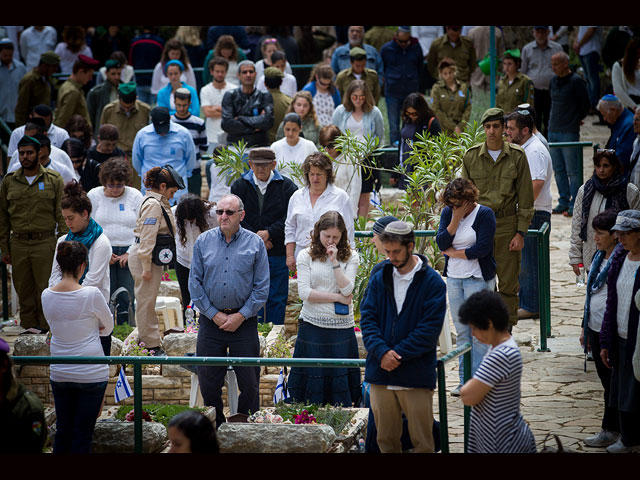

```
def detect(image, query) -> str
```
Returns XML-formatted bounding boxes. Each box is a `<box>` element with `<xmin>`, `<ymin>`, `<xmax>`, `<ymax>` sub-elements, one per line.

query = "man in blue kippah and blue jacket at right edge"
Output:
<box><xmin>597</xmin><ymin>94</ymin><xmax>636</xmax><ymax>176</ymax></box>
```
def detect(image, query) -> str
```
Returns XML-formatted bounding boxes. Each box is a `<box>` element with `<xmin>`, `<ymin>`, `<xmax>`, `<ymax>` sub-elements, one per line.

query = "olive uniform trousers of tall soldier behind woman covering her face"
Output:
<box><xmin>493</xmin><ymin>215</ymin><xmax>520</xmax><ymax>325</ymax></box>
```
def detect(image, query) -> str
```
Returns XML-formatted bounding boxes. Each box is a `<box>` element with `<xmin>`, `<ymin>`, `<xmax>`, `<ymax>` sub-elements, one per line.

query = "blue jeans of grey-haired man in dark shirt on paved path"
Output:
<box><xmin>549</xmin><ymin>131</ymin><xmax>582</xmax><ymax>209</ymax></box>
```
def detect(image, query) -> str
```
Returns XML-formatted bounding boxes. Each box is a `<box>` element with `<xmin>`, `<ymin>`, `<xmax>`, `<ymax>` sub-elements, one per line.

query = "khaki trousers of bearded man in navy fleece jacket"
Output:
<box><xmin>370</xmin><ymin>384</ymin><xmax>435</xmax><ymax>453</ymax></box>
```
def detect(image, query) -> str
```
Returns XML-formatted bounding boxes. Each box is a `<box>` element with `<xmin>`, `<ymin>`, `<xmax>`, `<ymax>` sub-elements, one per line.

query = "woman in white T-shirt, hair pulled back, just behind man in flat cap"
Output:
<box><xmin>271</xmin><ymin>112</ymin><xmax>318</xmax><ymax>187</ymax></box>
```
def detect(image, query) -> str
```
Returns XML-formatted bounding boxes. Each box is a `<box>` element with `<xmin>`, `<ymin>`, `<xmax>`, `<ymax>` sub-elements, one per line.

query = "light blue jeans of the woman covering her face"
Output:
<box><xmin>447</xmin><ymin>277</ymin><xmax>496</xmax><ymax>385</ymax></box>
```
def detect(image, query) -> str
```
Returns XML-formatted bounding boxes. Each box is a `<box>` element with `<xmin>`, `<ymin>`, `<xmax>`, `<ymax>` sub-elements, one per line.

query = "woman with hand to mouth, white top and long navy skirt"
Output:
<box><xmin>289</xmin><ymin>210</ymin><xmax>361</xmax><ymax>407</ymax></box>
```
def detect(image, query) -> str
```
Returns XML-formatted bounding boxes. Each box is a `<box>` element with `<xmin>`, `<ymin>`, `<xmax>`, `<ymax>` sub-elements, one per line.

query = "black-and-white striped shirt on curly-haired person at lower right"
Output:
<box><xmin>468</xmin><ymin>338</ymin><xmax>536</xmax><ymax>453</ymax></box>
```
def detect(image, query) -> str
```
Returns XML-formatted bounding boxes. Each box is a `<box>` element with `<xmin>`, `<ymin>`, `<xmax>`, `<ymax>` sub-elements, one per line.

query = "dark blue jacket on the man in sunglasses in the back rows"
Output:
<box><xmin>380</xmin><ymin>37</ymin><xmax>424</xmax><ymax>99</ymax></box>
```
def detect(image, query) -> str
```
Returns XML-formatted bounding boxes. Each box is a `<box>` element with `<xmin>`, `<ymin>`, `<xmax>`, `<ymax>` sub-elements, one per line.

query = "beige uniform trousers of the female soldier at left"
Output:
<box><xmin>129</xmin><ymin>244</ymin><xmax>162</xmax><ymax>348</ymax></box>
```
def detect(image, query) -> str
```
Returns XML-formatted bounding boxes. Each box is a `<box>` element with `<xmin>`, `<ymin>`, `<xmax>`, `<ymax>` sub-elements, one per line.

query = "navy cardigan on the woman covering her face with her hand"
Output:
<box><xmin>436</xmin><ymin>205</ymin><xmax>496</xmax><ymax>280</ymax></box>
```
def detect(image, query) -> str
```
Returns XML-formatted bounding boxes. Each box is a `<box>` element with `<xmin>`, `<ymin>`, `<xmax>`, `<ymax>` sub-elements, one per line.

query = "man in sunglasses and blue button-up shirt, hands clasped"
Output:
<box><xmin>189</xmin><ymin>194</ymin><xmax>269</xmax><ymax>427</ymax></box>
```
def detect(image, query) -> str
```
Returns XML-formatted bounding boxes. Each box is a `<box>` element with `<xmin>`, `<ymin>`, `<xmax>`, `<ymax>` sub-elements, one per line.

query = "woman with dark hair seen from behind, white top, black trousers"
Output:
<box><xmin>42</xmin><ymin>241</ymin><xmax>113</xmax><ymax>453</ymax></box>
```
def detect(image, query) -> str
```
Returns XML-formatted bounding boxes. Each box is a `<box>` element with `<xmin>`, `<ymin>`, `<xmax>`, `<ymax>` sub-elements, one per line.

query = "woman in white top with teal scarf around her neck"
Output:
<box><xmin>49</xmin><ymin>180</ymin><xmax>112</xmax><ymax>355</ymax></box>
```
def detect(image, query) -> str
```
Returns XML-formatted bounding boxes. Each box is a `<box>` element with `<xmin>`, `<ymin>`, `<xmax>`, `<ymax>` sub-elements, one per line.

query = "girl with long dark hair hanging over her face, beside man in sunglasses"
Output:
<box><xmin>171</xmin><ymin>193</ymin><xmax>218</xmax><ymax>313</ymax></box>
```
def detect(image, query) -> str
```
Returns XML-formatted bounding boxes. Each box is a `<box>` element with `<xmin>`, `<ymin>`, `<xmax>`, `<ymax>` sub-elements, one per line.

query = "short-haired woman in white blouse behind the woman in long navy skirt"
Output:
<box><xmin>284</xmin><ymin>152</ymin><xmax>355</xmax><ymax>271</ymax></box>
